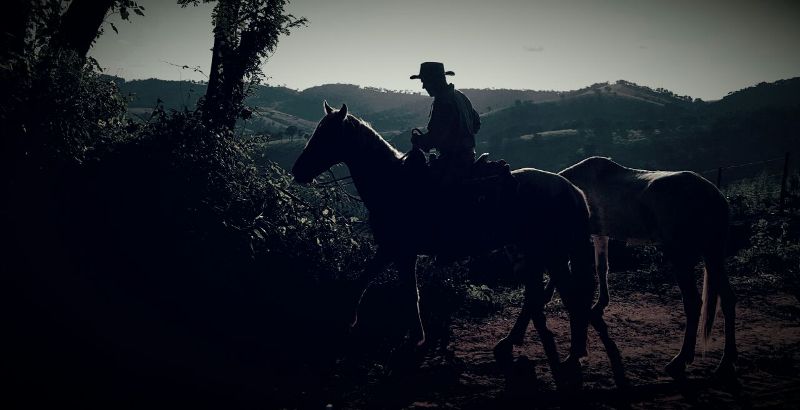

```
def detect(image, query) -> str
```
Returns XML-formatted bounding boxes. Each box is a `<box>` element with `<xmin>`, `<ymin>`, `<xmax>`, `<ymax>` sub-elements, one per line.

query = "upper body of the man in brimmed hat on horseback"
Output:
<box><xmin>410</xmin><ymin>62</ymin><xmax>481</xmax><ymax>185</ymax></box>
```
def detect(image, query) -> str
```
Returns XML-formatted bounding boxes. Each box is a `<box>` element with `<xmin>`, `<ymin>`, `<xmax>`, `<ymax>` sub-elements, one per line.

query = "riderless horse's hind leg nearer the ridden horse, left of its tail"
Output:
<box><xmin>665</xmin><ymin>254</ymin><xmax>703</xmax><ymax>378</ymax></box>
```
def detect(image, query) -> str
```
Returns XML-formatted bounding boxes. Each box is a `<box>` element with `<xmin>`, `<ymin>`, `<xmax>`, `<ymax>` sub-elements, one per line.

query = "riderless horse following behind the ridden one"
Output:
<box><xmin>560</xmin><ymin>157</ymin><xmax>736</xmax><ymax>378</ymax></box>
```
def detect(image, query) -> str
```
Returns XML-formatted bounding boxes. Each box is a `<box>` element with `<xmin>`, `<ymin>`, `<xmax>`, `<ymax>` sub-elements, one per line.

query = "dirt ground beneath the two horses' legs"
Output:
<box><xmin>337</xmin><ymin>287</ymin><xmax>800</xmax><ymax>409</ymax></box>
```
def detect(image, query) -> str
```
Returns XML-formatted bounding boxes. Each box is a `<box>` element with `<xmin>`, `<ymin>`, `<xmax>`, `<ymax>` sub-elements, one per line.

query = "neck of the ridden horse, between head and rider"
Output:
<box><xmin>345</xmin><ymin>125</ymin><xmax>400</xmax><ymax>213</ymax></box>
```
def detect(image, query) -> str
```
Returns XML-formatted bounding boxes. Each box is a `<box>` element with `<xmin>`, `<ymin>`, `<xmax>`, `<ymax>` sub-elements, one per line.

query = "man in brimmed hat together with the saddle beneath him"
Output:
<box><xmin>404</xmin><ymin>62</ymin><xmax>516</xmax><ymax>248</ymax></box>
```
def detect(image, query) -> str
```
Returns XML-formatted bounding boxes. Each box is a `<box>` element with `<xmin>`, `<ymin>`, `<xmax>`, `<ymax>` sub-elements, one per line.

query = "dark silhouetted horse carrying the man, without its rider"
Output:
<box><xmin>292</xmin><ymin>102</ymin><xmax>621</xmax><ymax>380</ymax></box>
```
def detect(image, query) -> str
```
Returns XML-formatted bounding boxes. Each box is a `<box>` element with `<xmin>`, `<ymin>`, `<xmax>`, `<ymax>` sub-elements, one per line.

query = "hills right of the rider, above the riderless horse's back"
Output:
<box><xmin>478</xmin><ymin>79</ymin><xmax>800</xmax><ymax>171</ymax></box>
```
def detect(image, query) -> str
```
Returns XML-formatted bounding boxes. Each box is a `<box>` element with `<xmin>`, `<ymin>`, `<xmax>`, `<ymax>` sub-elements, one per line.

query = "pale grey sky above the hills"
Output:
<box><xmin>90</xmin><ymin>0</ymin><xmax>800</xmax><ymax>100</ymax></box>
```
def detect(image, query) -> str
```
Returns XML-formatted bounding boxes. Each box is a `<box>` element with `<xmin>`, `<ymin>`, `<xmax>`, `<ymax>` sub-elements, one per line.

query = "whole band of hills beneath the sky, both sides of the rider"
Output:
<box><xmin>113</xmin><ymin>78</ymin><xmax>800</xmax><ymax>176</ymax></box>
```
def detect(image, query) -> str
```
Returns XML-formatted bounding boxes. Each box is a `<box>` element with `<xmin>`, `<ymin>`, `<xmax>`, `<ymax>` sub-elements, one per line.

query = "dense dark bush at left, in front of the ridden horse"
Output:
<box><xmin>0</xmin><ymin>52</ymin><xmax>372</xmax><ymax>407</ymax></box>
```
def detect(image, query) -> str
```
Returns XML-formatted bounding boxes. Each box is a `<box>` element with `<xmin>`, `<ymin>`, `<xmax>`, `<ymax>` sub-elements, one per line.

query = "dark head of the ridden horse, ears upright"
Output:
<box><xmin>292</xmin><ymin>101</ymin><xmax>347</xmax><ymax>183</ymax></box>
